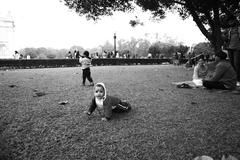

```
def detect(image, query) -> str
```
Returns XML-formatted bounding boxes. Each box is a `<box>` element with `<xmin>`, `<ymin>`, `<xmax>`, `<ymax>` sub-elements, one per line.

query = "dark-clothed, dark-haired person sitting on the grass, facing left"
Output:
<box><xmin>202</xmin><ymin>51</ymin><xmax>237</xmax><ymax>90</ymax></box>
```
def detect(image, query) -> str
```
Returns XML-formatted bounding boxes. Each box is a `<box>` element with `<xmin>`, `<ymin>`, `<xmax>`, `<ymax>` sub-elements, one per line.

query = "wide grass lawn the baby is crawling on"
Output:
<box><xmin>0</xmin><ymin>65</ymin><xmax>240</xmax><ymax>160</ymax></box>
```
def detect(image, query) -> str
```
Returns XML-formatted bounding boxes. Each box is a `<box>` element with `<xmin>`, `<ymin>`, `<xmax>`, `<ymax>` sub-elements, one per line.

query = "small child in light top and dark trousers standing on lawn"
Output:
<box><xmin>79</xmin><ymin>51</ymin><xmax>94</xmax><ymax>86</ymax></box>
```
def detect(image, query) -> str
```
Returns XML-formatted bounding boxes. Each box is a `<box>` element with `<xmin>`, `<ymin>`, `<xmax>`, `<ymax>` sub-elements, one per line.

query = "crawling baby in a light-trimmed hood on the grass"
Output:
<box><xmin>84</xmin><ymin>83</ymin><xmax>131</xmax><ymax>121</ymax></box>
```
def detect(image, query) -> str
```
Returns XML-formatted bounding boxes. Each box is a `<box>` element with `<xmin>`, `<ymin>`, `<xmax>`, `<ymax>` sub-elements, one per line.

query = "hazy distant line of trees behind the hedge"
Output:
<box><xmin>19</xmin><ymin>38</ymin><xmax>213</xmax><ymax>59</ymax></box>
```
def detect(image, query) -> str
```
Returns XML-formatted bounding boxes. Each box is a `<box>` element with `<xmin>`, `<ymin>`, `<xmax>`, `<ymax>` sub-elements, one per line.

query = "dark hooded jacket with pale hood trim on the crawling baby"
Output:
<box><xmin>88</xmin><ymin>83</ymin><xmax>121</xmax><ymax>119</ymax></box>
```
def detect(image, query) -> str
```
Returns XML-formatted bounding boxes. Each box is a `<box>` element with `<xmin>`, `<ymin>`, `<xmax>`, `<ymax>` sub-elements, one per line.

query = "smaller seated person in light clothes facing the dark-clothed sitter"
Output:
<box><xmin>193</xmin><ymin>58</ymin><xmax>208</xmax><ymax>80</ymax></box>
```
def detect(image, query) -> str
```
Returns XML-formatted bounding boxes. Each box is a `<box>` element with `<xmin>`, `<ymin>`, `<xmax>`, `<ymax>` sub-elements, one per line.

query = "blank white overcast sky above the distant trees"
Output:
<box><xmin>0</xmin><ymin>0</ymin><xmax>205</xmax><ymax>49</ymax></box>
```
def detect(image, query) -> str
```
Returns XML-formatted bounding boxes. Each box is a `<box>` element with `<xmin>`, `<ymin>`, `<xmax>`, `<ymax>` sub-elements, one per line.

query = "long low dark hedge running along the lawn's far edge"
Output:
<box><xmin>0</xmin><ymin>58</ymin><xmax>176</xmax><ymax>68</ymax></box>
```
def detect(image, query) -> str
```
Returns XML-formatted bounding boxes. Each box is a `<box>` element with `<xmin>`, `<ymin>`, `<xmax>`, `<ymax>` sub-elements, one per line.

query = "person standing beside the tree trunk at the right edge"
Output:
<box><xmin>227</xmin><ymin>16</ymin><xmax>240</xmax><ymax>86</ymax></box>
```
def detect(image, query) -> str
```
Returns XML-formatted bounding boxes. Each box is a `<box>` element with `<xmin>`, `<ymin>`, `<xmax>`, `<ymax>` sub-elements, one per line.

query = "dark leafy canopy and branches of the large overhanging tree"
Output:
<box><xmin>61</xmin><ymin>0</ymin><xmax>240</xmax><ymax>51</ymax></box>
